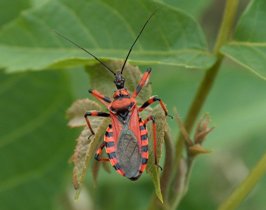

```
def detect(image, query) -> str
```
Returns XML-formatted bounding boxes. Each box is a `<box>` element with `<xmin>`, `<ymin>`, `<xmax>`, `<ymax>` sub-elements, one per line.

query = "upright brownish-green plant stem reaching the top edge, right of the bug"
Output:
<box><xmin>169</xmin><ymin>0</ymin><xmax>239</xmax><ymax>209</ymax></box>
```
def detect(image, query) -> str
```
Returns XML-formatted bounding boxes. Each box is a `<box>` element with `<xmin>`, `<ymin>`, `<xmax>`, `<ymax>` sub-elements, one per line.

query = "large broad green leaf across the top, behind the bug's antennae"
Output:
<box><xmin>0</xmin><ymin>0</ymin><xmax>215</xmax><ymax>72</ymax></box>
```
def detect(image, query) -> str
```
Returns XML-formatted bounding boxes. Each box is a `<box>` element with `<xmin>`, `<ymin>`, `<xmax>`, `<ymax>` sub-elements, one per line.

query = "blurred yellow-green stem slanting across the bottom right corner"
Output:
<box><xmin>218</xmin><ymin>153</ymin><xmax>266</xmax><ymax>210</ymax></box>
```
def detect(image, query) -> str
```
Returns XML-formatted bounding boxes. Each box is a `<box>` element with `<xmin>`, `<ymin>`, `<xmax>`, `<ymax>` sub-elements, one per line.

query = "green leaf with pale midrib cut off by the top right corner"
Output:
<box><xmin>221</xmin><ymin>0</ymin><xmax>266</xmax><ymax>80</ymax></box>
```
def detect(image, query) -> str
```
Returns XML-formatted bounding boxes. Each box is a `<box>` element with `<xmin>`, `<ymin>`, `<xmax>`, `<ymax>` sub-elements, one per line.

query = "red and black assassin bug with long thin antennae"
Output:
<box><xmin>56</xmin><ymin>12</ymin><xmax>171</xmax><ymax>180</ymax></box>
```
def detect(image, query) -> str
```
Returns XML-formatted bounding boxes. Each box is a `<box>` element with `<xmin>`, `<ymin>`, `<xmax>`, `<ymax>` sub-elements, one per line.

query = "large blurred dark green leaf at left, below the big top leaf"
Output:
<box><xmin>0</xmin><ymin>71</ymin><xmax>73</xmax><ymax>210</ymax></box>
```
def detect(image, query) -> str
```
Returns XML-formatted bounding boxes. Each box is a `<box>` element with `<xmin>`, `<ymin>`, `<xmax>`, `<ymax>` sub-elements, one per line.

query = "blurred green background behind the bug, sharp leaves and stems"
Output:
<box><xmin>0</xmin><ymin>0</ymin><xmax>266</xmax><ymax>210</ymax></box>
